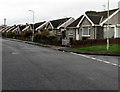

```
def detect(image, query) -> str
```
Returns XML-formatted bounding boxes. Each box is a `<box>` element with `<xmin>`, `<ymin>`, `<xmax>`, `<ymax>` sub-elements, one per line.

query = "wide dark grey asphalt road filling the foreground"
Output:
<box><xmin>2</xmin><ymin>40</ymin><xmax>118</xmax><ymax>90</ymax></box>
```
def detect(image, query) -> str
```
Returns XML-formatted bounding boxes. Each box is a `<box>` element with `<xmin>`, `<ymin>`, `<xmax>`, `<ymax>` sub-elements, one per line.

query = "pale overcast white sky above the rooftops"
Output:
<box><xmin>0</xmin><ymin>0</ymin><xmax>119</xmax><ymax>25</ymax></box>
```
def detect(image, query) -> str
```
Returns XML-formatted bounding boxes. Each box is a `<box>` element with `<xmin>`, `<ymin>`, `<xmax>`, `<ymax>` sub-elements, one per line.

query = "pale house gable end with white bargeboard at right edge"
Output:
<box><xmin>100</xmin><ymin>9</ymin><xmax>120</xmax><ymax>38</ymax></box>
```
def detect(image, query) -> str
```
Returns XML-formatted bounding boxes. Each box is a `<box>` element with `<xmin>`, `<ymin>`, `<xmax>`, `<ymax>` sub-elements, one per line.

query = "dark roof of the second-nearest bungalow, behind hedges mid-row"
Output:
<box><xmin>50</xmin><ymin>18</ymin><xmax>70</xmax><ymax>28</ymax></box>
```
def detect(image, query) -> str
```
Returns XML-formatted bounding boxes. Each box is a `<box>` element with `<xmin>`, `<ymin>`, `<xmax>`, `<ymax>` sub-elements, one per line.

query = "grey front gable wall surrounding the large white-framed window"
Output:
<box><xmin>79</xmin><ymin>18</ymin><xmax>95</xmax><ymax>40</ymax></box>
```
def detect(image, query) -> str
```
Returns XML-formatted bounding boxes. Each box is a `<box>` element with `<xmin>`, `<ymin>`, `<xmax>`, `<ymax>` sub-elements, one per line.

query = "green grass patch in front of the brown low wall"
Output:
<box><xmin>77</xmin><ymin>44</ymin><xmax>120</xmax><ymax>52</ymax></box>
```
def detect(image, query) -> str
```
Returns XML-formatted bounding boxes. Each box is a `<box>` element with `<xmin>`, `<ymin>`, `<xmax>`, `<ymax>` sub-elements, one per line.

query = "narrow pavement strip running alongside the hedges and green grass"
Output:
<box><xmin>7</xmin><ymin>39</ymin><xmax>120</xmax><ymax>56</ymax></box>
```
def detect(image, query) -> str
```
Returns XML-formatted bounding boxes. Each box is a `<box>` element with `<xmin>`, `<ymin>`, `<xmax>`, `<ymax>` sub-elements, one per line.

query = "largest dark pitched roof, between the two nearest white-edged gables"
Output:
<box><xmin>85</xmin><ymin>9</ymin><xmax>118</xmax><ymax>24</ymax></box>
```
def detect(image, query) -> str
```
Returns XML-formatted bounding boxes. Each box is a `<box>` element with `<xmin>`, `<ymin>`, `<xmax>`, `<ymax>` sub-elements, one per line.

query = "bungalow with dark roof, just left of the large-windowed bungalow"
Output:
<box><xmin>46</xmin><ymin>17</ymin><xmax>74</xmax><ymax>39</ymax></box>
